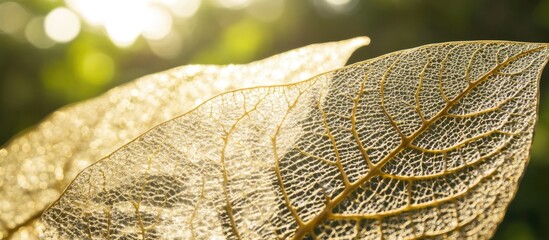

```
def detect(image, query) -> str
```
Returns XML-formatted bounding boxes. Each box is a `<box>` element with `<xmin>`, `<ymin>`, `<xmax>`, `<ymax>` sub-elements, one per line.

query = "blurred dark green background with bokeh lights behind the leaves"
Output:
<box><xmin>0</xmin><ymin>0</ymin><xmax>549</xmax><ymax>237</ymax></box>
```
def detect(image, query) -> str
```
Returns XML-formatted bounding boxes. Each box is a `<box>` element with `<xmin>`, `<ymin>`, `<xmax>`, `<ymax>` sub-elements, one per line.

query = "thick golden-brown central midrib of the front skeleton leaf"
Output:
<box><xmin>292</xmin><ymin>45</ymin><xmax>547</xmax><ymax>239</ymax></box>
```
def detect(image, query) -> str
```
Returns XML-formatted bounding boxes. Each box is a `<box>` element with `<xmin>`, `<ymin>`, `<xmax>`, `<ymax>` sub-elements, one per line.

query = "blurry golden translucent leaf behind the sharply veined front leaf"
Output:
<box><xmin>0</xmin><ymin>37</ymin><xmax>369</xmax><ymax>238</ymax></box>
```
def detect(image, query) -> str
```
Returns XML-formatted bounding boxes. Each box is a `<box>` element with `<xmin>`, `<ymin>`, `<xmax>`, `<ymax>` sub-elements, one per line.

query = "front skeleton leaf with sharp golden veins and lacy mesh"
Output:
<box><xmin>43</xmin><ymin>41</ymin><xmax>549</xmax><ymax>239</ymax></box>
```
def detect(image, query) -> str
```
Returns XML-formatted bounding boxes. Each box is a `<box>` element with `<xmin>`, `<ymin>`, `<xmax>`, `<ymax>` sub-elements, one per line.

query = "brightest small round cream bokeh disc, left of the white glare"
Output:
<box><xmin>44</xmin><ymin>7</ymin><xmax>80</xmax><ymax>43</ymax></box>
